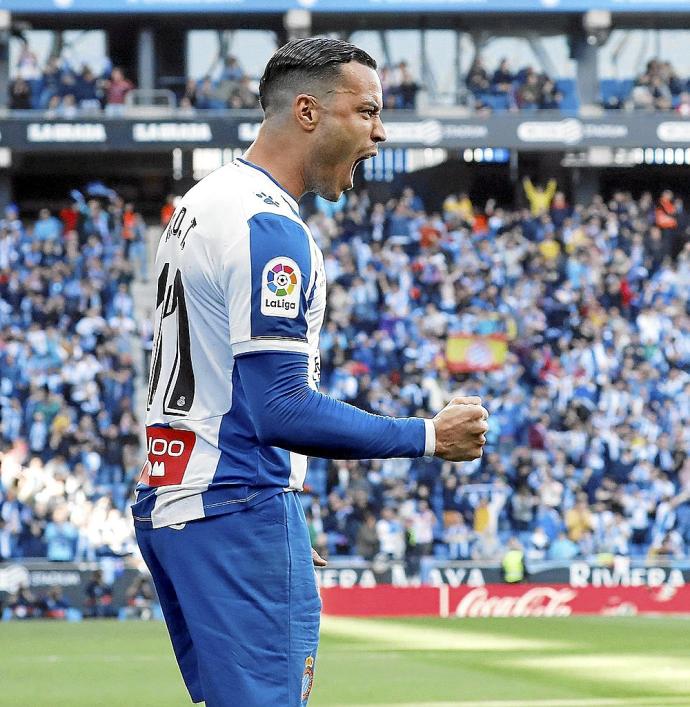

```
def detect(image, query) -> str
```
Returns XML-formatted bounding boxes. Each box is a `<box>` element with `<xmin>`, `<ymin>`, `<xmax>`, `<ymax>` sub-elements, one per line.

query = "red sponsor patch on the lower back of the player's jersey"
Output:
<box><xmin>139</xmin><ymin>427</ymin><xmax>196</xmax><ymax>486</ymax></box>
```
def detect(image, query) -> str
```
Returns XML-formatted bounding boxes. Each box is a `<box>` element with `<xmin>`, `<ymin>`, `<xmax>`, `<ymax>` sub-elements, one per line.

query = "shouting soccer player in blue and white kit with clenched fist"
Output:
<box><xmin>133</xmin><ymin>39</ymin><xmax>488</xmax><ymax>707</ymax></box>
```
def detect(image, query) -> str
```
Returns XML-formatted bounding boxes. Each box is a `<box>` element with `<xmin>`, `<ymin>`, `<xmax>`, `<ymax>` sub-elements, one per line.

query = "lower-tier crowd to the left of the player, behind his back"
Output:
<box><xmin>0</xmin><ymin>184</ymin><xmax>145</xmax><ymax>561</ymax></box>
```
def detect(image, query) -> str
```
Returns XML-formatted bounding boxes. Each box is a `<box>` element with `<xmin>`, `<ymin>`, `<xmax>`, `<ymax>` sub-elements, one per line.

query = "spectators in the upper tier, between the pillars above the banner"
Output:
<box><xmin>10</xmin><ymin>35</ymin><xmax>690</xmax><ymax>113</ymax></box>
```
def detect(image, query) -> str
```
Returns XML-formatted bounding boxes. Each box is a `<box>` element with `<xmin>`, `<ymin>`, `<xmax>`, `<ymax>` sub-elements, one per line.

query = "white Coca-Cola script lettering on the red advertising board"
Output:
<box><xmin>455</xmin><ymin>587</ymin><xmax>578</xmax><ymax>616</ymax></box>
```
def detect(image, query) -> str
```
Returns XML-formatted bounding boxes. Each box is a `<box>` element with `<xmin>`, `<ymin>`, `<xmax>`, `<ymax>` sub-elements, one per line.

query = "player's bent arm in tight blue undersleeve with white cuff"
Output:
<box><xmin>236</xmin><ymin>353</ymin><xmax>435</xmax><ymax>459</ymax></box>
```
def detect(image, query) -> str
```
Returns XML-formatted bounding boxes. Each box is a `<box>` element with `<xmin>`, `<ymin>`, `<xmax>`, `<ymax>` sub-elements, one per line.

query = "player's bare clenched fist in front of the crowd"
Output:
<box><xmin>433</xmin><ymin>397</ymin><xmax>489</xmax><ymax>462</ymax></box>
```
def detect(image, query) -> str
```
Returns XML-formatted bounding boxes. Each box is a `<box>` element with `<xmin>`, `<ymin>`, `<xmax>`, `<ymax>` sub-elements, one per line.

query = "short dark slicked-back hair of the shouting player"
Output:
<box><xmin>259</xmin><ymin>37</ymin><xmax>376</xmax><ymax>112</ymax></box>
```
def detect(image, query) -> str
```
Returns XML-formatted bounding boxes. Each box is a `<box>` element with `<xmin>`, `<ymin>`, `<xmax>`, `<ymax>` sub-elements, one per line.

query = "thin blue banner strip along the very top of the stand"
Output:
<box><xmin>0</xmin><ymin>0</ymin><xmax>690</xmax><ymax>15</ymax></box>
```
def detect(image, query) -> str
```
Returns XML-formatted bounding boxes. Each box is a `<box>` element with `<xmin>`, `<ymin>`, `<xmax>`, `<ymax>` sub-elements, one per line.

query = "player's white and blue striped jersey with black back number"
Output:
<box><xmin>133</xmin><ymin>160</ymin><xmax>326</xmax><ymax>527</ymax></box>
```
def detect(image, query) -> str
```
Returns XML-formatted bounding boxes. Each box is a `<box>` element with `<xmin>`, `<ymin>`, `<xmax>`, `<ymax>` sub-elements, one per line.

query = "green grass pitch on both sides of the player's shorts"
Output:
<box><xmin>0</xmin><ymin>617</ymin><xmax>690</xmax><ymax>707</ymax></box>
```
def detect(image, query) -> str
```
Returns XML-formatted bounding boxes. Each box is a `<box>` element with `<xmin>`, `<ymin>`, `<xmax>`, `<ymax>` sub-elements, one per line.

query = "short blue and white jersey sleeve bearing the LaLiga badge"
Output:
<box><xmin>223</xmin><ymin>212</ymin><xmax>312</xmax><ymax>356</ymax></box>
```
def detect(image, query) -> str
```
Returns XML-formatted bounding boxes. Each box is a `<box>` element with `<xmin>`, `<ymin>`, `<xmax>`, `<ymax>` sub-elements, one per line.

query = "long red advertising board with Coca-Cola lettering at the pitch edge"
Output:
<box><xmin>321</xmin><ymin>584</ymin><xmax>690</xmax><ymax>617</ymax></box>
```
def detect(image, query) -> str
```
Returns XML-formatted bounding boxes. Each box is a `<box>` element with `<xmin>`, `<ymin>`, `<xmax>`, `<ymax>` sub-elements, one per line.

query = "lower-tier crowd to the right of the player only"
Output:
<box><xmin>300</xmin><ymin>181</ymin><xmax>690</xmax><ymax>561</ymax></box>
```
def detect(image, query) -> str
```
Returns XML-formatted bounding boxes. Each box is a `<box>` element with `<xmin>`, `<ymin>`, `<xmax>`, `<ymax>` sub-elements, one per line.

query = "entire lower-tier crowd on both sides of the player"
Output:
<box><xmin>0</xmin><ymin>173</ymin><xmax>690</xmax><ymax>569</ymax></box>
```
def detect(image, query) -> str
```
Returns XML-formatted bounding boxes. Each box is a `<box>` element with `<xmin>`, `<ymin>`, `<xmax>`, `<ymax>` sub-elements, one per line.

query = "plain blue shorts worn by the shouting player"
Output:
<box><xmin>136</xmin><ymin>492</ymin><xmax>321</xmax><ymax>707</ymax></box>
